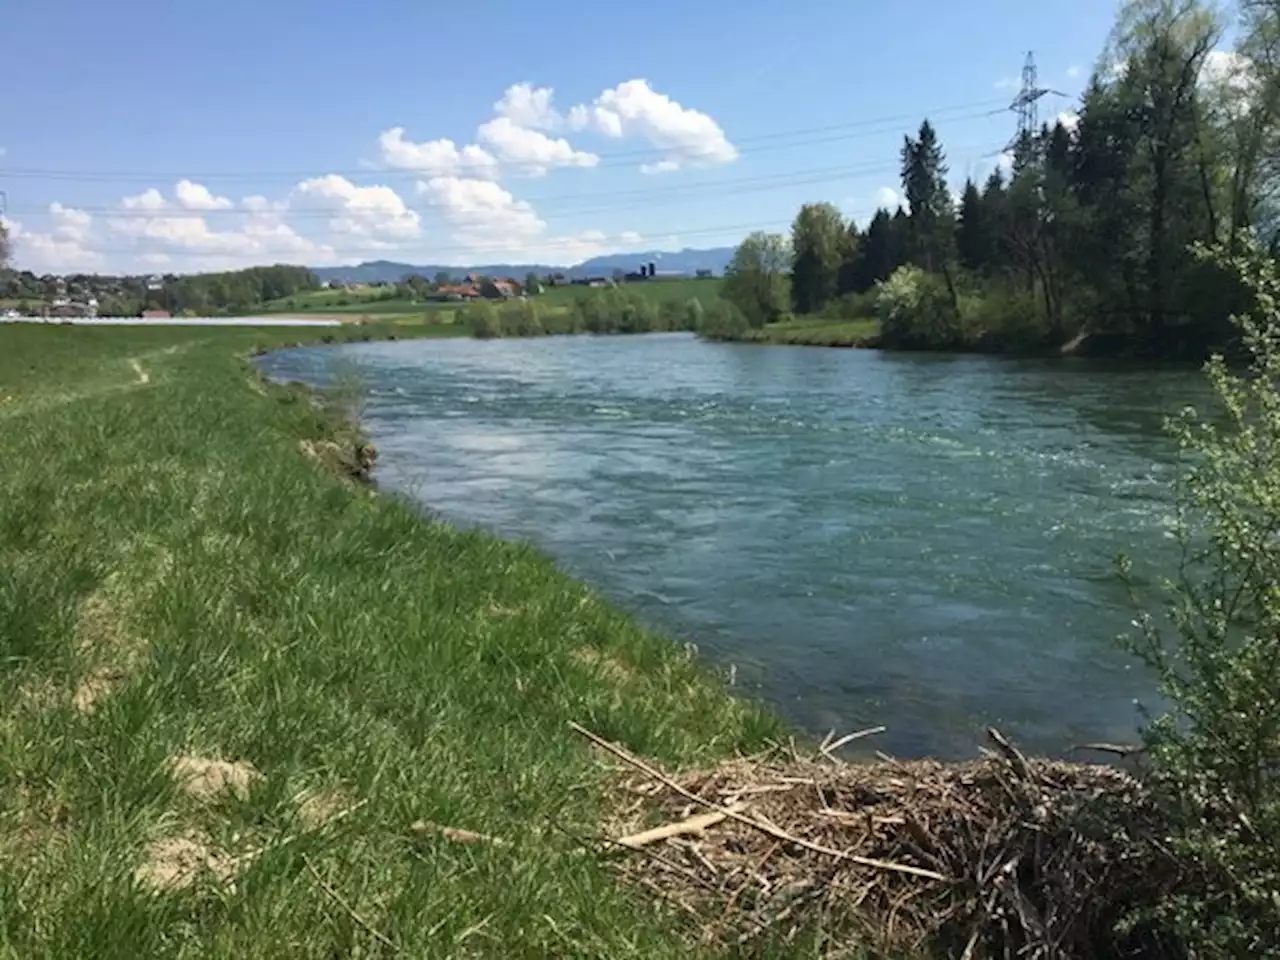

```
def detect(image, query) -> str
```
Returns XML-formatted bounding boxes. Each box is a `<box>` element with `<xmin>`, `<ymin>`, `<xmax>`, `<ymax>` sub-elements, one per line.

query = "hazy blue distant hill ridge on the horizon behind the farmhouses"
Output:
<box><xmin>314</xmin><ymin>247</ymin><xmax>733</xmax><ymax>283</ymax></box>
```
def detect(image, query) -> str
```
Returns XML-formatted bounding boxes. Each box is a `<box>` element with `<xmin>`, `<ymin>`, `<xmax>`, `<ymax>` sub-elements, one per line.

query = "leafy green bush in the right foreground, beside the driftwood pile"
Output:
<box><xmin>1121</xmin><ymin>241</ymin><xmax>1280</xmax><ymax>957</ymax></box>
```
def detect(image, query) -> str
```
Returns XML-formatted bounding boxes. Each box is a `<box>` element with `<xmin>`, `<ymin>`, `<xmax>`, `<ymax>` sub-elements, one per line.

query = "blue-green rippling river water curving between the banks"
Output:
<box><xmin>262</xmin><ymin>334</ymin><xmax>1207</xmax><ymax>758</ymax></box>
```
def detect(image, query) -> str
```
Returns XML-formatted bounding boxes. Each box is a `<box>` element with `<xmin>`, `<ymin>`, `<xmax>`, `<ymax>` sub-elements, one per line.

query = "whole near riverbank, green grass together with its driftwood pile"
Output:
<box><xmin>0</xmin><ymin>328</ymin><xmax>1228</xmax><ymax>957</ymax></box>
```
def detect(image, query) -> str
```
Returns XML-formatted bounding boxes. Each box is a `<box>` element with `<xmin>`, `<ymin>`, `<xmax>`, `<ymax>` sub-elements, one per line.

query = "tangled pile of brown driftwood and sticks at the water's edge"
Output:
<box><xmin>576</xmin><ymin>727</ymin><xmax>1179</xmax><ymax>959</ymax></box>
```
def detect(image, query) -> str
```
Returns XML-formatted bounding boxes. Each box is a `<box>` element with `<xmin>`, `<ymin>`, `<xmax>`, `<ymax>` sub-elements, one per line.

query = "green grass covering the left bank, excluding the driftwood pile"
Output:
<box><xmin>0</xmin><ymin>326</ymin><xmax>778</xmax><ymax>957</ymax></box>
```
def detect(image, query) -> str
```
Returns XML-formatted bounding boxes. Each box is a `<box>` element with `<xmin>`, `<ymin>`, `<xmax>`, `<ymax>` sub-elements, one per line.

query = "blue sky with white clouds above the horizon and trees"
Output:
<box><xmin>0</xmin><ymin>0</ymin><xmax>1116</xmax><ymax>273</ymax></box>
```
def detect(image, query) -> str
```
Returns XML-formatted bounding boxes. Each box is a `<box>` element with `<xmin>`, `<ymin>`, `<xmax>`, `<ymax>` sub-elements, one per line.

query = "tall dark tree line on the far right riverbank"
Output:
<box><xmin>724</xmin><ymin>0</ymin><xmax>1280</xmax><ymax>353</ymax></box>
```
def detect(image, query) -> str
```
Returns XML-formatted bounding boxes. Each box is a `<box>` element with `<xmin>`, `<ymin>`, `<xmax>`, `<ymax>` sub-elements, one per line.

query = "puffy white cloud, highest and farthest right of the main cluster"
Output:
<box><xmin>570</xmin><ymin>79</ymin><xmax>739</xmax><ymax>173</ymax></box>
